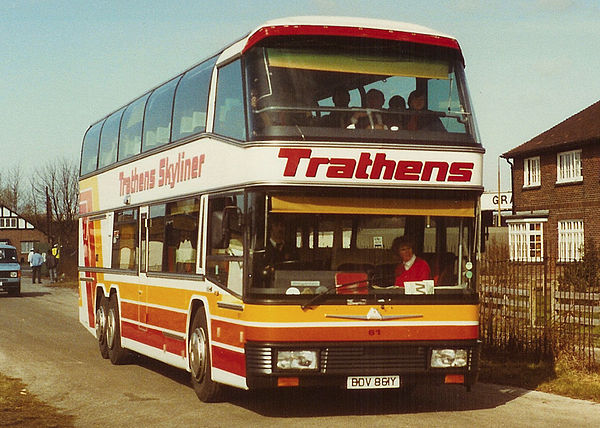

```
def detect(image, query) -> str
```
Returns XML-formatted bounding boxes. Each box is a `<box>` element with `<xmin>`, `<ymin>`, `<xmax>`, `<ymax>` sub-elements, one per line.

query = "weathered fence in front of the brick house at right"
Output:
<box><xmin>479</xmin><ymin>251</ymin><xmax>600</xmax><ymax>367</ymax></box>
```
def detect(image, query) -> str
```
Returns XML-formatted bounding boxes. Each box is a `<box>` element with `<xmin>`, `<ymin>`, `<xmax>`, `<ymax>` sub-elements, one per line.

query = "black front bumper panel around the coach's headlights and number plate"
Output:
<box><xmin>246</xmin><ymin>340</ymin><xmax>480</xmax><ymax>389</ymax></box>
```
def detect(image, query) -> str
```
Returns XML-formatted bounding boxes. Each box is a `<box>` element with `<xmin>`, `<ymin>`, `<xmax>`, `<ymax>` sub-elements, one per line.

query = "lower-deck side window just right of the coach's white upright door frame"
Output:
<box><xmin>148</xmin><ymin>198</ymin><xmax>200</xmax><ymax>273</ymax></box>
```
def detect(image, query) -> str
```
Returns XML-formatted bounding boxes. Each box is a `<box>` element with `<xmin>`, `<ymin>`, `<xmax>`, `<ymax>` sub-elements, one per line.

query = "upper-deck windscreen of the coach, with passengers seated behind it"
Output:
<box><xmin>245</xmin><ymin>37</ymin><xmax>478</xmax><ymax>145</ymax></box>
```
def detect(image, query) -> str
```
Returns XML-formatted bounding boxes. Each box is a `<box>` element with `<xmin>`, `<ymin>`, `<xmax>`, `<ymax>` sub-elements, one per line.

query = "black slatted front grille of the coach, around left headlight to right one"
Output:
<box><xmin>246</xmin><ymin>344</ymin><xmax>428</xmax><ymax>375</ymax></box>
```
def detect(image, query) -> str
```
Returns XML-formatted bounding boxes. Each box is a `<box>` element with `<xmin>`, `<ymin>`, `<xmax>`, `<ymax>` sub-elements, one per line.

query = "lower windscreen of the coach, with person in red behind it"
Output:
<box><xmin>248</xmin><ymin>193</ymin><xmax>475</xmax><ymax>299</ymax></box>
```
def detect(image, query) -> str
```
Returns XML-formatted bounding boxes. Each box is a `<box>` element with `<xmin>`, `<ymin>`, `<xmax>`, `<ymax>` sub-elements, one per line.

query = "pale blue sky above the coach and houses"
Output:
<box><xmin>0</xmin><ymin>0</ymin><xmax>600</xmax><ymax>191</ymax></box>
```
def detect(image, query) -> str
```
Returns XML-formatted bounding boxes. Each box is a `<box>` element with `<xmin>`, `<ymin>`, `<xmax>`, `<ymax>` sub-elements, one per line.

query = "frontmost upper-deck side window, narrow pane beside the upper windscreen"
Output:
<box><xmin>214</xmin><ymin>60</ymin><xmax>246</xmax><ymax>141</ymax></box>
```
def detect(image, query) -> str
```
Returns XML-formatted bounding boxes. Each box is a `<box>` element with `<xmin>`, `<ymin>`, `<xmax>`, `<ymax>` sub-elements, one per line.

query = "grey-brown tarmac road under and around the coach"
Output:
<box><xmin>0</xmin><ymin>279</ymin><xmax>600</xmax><ymax>428</ymax></box>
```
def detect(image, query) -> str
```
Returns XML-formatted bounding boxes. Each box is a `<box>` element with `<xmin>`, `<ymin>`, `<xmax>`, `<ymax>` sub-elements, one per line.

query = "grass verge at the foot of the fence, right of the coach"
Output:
<box><xmin>479</xmin><ymin>355</ymin><xmax>600</xmax><ymax>403</ymax></box>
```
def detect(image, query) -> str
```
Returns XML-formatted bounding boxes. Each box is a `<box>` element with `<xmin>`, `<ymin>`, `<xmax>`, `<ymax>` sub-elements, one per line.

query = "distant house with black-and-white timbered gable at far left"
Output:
<box><xmin>0</xmin><ymin>205</ymin><xmax>48</xmax><ymax>260</ymax></box>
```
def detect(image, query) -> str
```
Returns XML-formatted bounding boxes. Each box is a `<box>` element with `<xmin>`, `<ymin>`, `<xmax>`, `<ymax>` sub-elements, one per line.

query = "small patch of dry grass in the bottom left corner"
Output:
<box><xmin>0</xmin><ymin>373</ymin><xmax>74</xmax><ymax>428</ymax></box>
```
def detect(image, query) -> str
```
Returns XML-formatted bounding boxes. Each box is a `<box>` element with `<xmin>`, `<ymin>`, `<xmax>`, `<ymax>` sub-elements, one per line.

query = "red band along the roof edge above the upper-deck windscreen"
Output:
<box><xmin>243</xmin><ymin>25</ymin><xmax>460</xmax><ymax>52</ymax></box>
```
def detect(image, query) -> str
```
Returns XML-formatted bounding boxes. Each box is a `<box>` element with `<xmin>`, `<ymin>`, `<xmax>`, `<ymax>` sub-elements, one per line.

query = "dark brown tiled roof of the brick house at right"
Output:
<box><xmin>502</xmin><ymin>101</ymin><xmax>600</xmax><ymax>158</ymax></box>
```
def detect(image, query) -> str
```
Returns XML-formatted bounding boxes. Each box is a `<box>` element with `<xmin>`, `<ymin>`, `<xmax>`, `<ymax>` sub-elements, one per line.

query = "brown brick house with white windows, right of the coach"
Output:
<box><xmin>502</xmin><ymin>101</ymin><xmax>600</xmax><ymax>261</ymax></box>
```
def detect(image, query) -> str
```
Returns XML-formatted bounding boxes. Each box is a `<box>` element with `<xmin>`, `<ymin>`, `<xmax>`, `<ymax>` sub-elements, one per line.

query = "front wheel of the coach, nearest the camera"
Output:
<box><xmin>188</xmin><ymin>308</ymin><xmax>223</xmax><ymax>403</ymax></box>
